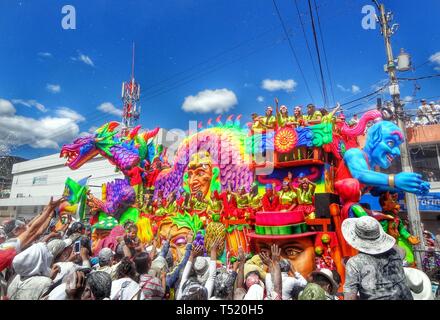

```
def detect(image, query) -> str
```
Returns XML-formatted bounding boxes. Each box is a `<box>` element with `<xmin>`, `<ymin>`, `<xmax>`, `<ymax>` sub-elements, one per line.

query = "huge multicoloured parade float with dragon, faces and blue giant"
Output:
<box><xmin>60</xmin><ymin>99</ymin><xmax>429</xmax><ymax>290</ymax></box>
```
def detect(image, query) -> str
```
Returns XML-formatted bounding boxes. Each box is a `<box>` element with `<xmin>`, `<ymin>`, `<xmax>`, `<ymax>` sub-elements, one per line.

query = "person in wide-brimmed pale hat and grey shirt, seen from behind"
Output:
<box><xmin>342</xmin><ymin>216</ymin><xmax>413</xmax><ymax>300</ymax></box>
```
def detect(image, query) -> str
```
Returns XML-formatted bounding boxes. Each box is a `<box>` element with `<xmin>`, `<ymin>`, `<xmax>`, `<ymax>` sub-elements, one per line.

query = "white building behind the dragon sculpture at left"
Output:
<box><xmin>0</xmin><ymin>130</ymin><xmax>182</xmax><ymax>222</ymax></box>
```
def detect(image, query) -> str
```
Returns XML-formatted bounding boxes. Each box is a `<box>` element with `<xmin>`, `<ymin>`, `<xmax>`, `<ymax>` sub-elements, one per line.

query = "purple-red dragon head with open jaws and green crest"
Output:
<box><xmin>60</xmin><ymin>122</ymin><xmax>119</xmax><ymax>170</ymax></box>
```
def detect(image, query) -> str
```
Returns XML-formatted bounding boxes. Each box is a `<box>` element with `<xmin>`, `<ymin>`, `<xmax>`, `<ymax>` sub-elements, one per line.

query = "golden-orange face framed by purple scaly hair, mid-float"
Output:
<box><xmin>187</xmin><ymin>151</ymin><xmax>214</xmax><ymax>198</ymax></box>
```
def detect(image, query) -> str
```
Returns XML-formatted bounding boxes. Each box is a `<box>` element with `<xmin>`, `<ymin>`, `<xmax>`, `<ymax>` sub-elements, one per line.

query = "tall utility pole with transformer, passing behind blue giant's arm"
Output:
<box><xmin>373</xmin><ymin>0</ymin><xmax>425</xmax><ymax>269</ymax></box>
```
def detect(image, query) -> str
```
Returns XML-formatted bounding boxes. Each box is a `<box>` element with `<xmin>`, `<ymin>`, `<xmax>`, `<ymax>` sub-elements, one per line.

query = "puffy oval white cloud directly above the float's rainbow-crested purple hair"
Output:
<box><xmin>182</xmin><ymin>88</ymin><xmax>238</xmax><ymax>114</ymax></box>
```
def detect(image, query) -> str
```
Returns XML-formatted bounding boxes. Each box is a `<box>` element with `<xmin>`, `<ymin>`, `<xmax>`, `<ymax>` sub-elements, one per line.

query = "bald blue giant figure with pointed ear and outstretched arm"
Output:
<box><xmin>336</xmin><ymin>121</ymin><xmax>430</xmax><ymax>194</ymax></box>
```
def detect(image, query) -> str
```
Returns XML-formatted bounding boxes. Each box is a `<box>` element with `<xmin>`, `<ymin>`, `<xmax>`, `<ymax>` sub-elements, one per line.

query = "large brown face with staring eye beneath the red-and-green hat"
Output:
<box><xmin>255</xmin><ymin>236</ymin><xmax>315</xmax><ymax>277</ymax></box>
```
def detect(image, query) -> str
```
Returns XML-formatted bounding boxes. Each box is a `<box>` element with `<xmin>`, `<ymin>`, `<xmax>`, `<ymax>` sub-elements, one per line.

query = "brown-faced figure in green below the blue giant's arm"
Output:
<box><xmin>379</xmin><ymin>192</ymin><xmax>420</xmax><ymax>266</ymax></box>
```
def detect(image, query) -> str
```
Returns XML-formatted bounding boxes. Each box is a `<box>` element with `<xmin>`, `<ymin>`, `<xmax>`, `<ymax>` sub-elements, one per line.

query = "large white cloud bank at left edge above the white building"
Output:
<box><xmin>0</xmin><ymin>99</ymin><xmax>79</xmax><ymax>149</ymax></box>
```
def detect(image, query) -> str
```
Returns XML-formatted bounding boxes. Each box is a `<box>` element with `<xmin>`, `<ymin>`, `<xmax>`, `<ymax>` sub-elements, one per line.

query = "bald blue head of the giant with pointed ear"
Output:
<box><xmin>367</xmin><ymin>121</ymin><xmax>403</xmax><ymax>169</ymax></box>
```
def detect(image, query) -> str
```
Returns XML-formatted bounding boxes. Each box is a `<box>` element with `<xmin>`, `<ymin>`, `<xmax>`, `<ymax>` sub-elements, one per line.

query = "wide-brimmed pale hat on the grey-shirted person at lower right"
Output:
<box><xmin>342</xmin><ymin>216</ymin><xmax>396</xmax><ymax>254</ymax></box>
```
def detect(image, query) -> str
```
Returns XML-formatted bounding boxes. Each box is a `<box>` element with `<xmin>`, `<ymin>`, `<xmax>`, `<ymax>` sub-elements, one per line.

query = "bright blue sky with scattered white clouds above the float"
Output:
<box><xmin>0</xmin><ymin>0</ymin><xmax>440</xmax><ymax>158</ymax></box>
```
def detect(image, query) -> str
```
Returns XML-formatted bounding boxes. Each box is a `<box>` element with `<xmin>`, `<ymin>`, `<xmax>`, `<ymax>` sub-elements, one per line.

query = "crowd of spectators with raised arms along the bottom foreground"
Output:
<box><xmin>0</xmin><ymin>199</ymin><xmax>433</xmax><ymax>300</ymax></box>
